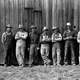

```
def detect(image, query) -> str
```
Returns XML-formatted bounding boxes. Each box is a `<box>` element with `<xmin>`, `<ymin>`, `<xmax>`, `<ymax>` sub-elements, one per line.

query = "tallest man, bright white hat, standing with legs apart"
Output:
<box><xmin>63</xmin><ymin>22</ymin><xmax>75</xmax><ymax>65</ymax></box>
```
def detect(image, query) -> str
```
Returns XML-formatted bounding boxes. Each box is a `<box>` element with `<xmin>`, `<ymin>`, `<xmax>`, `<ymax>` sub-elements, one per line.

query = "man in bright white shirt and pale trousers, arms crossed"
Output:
<box><xmin>15</xmin><ymin>24</ymin><xmax>28</xmax><ymax>67</ymax></box>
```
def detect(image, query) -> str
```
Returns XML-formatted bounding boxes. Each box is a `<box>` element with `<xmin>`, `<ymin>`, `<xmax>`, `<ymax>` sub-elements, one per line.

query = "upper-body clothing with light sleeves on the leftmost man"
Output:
<box><xmin>1</xmin><ymin>32</ymin><xmax>13</xmax><ymax>47</ymax></box>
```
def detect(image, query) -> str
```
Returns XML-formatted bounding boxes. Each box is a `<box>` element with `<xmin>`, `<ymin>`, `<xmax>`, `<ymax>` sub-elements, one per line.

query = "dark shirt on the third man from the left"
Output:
<box><xmin>29</xmin><ymin>32</ymin><xmax>39</xmax><ymax>44</ymax></box>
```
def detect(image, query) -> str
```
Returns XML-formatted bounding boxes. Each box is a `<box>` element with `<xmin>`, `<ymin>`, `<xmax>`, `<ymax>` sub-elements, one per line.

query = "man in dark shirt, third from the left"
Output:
<box><xmin>29</xmin><ymin>25</ymin><xmax>39</xmax><ymax>67</ymax></box>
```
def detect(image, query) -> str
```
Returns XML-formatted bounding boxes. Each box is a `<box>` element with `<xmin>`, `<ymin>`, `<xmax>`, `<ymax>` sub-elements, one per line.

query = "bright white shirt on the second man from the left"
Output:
<box><xmin>15</xmin><ymin>31</ymin><xmax>28</xmax><ymax>46</ymax></box>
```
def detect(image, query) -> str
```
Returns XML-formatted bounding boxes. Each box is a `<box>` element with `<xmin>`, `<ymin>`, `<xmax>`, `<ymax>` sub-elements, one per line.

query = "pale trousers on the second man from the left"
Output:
<box><xmin>16</xmin><ymin>45</ymin><xmax>26</xmax><ymax>65</ymax></box>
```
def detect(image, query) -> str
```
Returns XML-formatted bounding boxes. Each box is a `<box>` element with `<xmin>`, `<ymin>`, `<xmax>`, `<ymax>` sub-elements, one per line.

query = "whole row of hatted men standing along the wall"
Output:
<box><xmin>1</xmin><ymin>22</ymin><xmax>80</xmax><ymax>67</ymax></box>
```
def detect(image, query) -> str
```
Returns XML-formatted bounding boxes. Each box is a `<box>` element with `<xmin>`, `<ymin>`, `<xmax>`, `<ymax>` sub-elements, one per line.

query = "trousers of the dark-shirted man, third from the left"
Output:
<box><xmin>29</xmin><ymin>44</ymin><xmax>38</xmax><ymax>65</ymax></box>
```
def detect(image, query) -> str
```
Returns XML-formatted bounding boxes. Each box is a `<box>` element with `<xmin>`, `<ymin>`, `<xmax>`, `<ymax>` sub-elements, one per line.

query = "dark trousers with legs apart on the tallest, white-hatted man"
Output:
<box><xmin>64</xmin><ymin>40</ymin><xmax>75</xmax><ymax>64</ymax></box>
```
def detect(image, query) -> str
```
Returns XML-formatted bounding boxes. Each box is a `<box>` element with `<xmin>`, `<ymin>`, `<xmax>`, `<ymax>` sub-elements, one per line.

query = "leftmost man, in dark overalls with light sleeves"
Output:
<box><xmin>1</xmin><ymin>24</ymin><xmax>13</xmax><ymax>66</ymax></box>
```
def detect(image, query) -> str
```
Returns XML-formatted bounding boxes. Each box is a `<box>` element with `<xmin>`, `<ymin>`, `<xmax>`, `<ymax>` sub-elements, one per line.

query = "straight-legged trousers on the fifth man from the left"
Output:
<box><xmin>52</xmin><ymin>42</ymin><xmax>61</xmax><ymax>65</ymax></box>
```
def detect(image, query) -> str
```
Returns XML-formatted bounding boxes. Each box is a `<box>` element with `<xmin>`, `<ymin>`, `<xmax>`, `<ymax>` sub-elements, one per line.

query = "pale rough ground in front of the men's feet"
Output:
<box><xmin>0</xmin><ymin>65</ymin><xmax>80</xmax><ymax>80</ymax></box>
